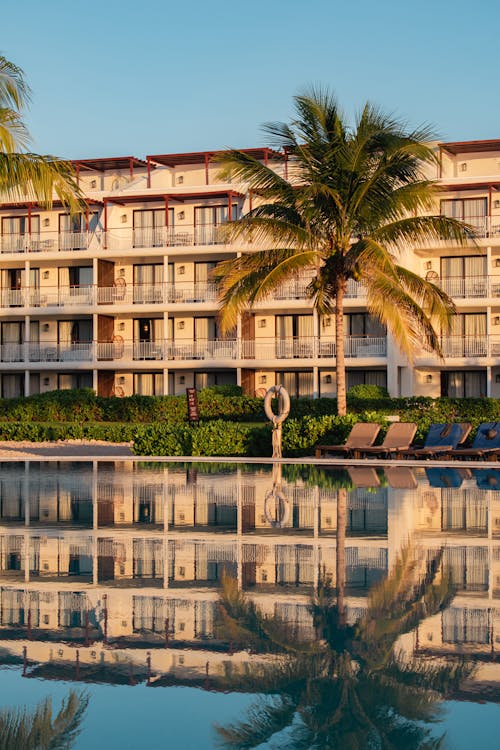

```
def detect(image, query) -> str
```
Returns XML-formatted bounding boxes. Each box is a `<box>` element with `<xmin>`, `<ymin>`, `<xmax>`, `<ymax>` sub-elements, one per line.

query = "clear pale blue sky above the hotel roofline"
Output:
<box><xmin>0</xmin><ymin>0</ymin><xmax>500</xmax><ymax>158</ymax></box>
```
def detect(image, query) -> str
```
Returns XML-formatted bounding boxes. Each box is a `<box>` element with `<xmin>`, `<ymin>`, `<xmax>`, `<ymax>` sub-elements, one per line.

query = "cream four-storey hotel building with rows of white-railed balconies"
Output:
<box><xmin>0</xmin><ymin>140</ymin><xmax>500</xmax><ymax>397</ymax></box>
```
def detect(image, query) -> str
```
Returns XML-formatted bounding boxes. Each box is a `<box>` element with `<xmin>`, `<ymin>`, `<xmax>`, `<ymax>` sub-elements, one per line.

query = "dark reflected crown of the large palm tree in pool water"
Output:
<box><xmin>217</xmin><ymin>546</ymin><xmax>466</xmax><ymax>750</ymax></box>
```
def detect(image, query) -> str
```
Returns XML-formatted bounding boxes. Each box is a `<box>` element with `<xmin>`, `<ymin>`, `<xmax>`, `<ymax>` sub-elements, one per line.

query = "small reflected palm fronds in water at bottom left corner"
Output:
<box><xmin>0</xmin><ymin>690</ymin><xmax>89</xmax><ymax>750</ymax></box>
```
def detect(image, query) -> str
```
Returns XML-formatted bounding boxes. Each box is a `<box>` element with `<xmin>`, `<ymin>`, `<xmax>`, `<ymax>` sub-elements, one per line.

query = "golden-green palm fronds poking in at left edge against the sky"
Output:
<box><xmin>0</xmin><ymin>56</ymin><xmax>82</xmax><ymax>213</ymax></box>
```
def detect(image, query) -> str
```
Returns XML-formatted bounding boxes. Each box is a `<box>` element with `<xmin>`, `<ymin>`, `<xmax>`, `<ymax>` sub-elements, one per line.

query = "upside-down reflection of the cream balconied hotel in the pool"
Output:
<box><xmin>0</xmin><ymin>462</ymin><xmax>500</xmax><ymax>692</ymax></box>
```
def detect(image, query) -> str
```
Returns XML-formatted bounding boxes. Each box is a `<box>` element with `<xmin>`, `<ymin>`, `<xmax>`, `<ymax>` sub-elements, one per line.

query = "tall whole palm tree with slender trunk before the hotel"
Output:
<box><xmin>214</xmin><ymin>89</ymin><xmax>473</xmax><ymax>415</ymax></box>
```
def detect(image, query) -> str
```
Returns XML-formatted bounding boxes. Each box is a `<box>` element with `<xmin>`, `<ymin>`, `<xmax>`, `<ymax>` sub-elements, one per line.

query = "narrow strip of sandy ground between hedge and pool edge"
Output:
<box><xmin>0</xmin><ymin>440</ymin><xmax>133</xmax><ymax>459</ymax></box>
